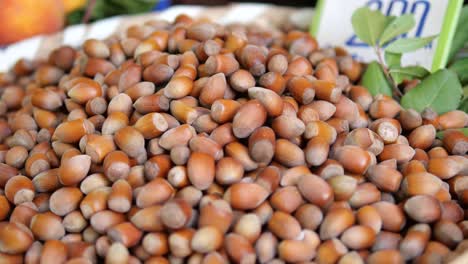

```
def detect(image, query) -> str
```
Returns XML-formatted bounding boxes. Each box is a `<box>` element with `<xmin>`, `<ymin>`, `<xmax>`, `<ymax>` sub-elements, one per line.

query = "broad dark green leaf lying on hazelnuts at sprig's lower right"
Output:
<box><xmin>400</xmin><ymin>69</ymin><xmax>462</xmax><ymax>114</ymax></box>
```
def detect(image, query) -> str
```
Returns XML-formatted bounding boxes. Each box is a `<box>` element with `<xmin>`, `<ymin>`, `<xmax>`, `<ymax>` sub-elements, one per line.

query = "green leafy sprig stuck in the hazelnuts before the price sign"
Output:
<box><xmin>351</xmin><ymin>7</ymin><xmax>460</xmax><ymax>114</ymax></box>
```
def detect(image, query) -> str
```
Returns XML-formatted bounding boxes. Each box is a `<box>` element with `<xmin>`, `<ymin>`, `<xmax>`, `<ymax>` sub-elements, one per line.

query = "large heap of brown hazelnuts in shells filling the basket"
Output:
<box><xmin>0</xmin><ymin>12</ymin><xmax>468</xmax><ymax>264</ymax></box>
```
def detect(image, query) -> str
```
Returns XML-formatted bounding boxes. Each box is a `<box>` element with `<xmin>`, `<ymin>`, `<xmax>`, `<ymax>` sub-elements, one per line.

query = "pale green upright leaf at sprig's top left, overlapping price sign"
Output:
<box><xmin>351</xmin><ymin>7</ymin><xmax>388</xmax><ymax>46</ymax></box>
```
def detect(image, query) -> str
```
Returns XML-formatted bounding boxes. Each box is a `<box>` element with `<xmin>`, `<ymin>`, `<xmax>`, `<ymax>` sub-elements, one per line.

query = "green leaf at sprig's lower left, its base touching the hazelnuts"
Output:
<box><xmin>362</xmin><ymin>61</ymin><xmax>392</xmax><ymax>96</ymax></box>
